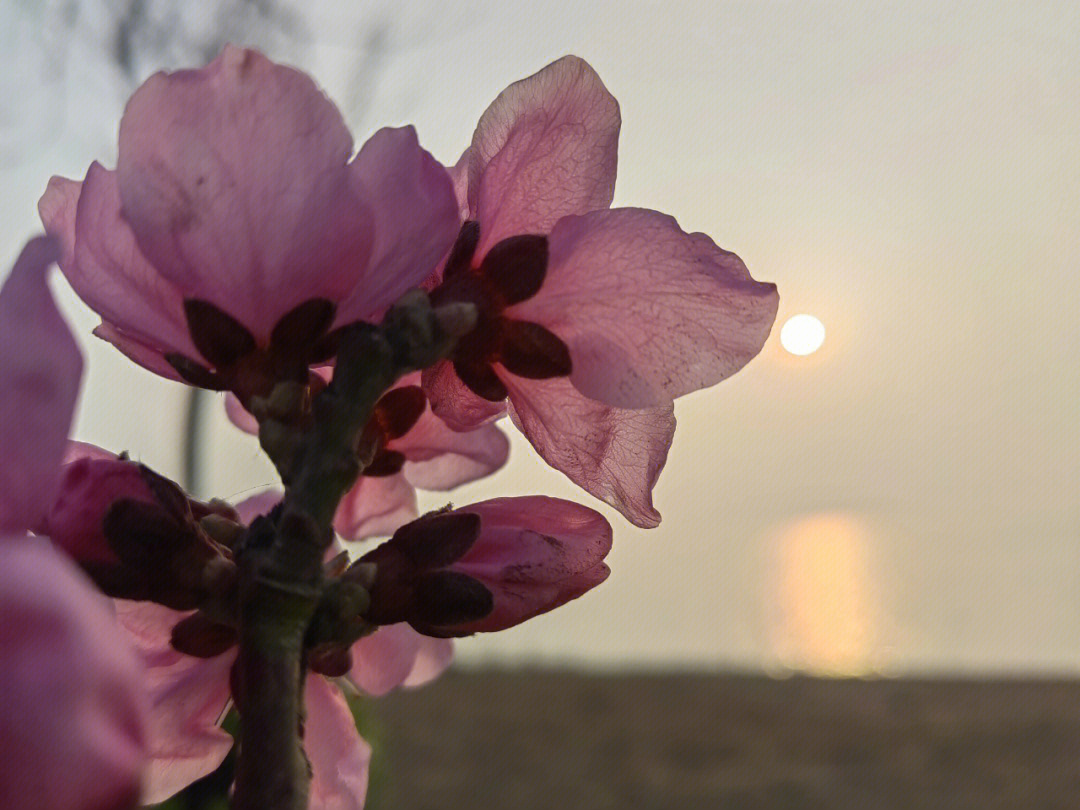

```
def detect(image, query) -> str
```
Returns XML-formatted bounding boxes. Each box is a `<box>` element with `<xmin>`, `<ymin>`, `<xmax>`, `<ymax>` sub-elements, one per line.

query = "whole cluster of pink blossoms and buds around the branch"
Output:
<box><xmin>0</xmin><ymin>46</ymin><xmax>778</xmax><ymax>810</ymax></box>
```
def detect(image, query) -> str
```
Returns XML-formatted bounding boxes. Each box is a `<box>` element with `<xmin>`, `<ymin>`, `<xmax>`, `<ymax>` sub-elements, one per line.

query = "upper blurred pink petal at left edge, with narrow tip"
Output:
<box><xmin>0</xmin><ymin>238</ymin><xmax>82</xmax><ymax>532</ymax></box>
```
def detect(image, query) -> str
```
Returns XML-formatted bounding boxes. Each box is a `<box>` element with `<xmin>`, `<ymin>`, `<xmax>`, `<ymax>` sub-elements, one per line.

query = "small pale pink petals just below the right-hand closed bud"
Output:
<box><xmin>349</xmin><ymin>622</ymin><xmax>454</xmax><ymax>697</ymax></box>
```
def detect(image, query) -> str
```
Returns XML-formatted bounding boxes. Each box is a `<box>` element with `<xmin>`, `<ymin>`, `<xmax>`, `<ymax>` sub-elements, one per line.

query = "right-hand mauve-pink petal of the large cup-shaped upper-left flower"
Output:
<box><xmin>336</xmin><ymin>126</ymin><xmax>460</xmax><ymax>324</ymax></box>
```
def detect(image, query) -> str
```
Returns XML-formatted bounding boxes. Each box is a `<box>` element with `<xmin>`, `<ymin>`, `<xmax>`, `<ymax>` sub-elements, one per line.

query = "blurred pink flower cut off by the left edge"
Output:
<box><xmin>0</xmin><ymin>239</ymin><xmax>146</xmax><ymax>810</ymax></box>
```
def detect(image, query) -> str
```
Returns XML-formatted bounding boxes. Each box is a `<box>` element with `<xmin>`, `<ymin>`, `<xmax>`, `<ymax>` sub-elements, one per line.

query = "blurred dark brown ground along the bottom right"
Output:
<box><xmin>368</xmin><ymin>673</ymin><xmax>1080</xmax><ymax>810</ymax></box>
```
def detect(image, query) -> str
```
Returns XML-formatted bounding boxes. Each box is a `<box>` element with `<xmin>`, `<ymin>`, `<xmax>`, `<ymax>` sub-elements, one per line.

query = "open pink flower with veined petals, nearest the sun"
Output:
<box><xmin>423</xmin><ymin>56</ymin><xmax>777</xmax><ymax>526</ymax></box>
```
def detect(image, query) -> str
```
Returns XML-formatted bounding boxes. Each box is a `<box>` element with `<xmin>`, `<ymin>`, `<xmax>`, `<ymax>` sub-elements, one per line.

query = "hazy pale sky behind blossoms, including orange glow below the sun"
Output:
<box><xmin>0</xmin><ymin>0</ymin><xmax>1080</xmax><ymax>674</ymax></box>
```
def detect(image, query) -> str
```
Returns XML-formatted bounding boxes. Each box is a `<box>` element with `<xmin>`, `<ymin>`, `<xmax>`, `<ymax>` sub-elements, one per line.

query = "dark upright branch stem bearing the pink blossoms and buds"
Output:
<box><xmin>233</xmin><ymin>291</ymin><xmax>476</xmax><ymax>810</ymax></box>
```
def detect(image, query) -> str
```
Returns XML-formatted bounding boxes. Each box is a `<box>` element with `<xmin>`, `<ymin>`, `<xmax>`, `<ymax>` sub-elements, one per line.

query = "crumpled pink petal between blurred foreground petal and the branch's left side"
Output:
<box><xmin>116</xmin><ymin>600</ymin><xmax>235</xmax><ymax>805</ymax></box>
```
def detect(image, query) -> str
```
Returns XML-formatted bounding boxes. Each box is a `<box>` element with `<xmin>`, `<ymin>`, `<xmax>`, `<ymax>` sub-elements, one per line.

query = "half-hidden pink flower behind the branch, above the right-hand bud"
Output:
<box><xmin>226</xmin><ymin>368</ymin><xmax>510</xmax><ymax>540</ymax></box>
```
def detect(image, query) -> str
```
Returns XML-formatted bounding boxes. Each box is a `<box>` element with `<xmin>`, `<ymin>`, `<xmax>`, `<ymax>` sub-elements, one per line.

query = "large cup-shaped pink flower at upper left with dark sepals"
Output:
<box><xmin>39</xmin><ymin>46</ymin><xmax>457</xmax><ymax>402</ymax></box>
